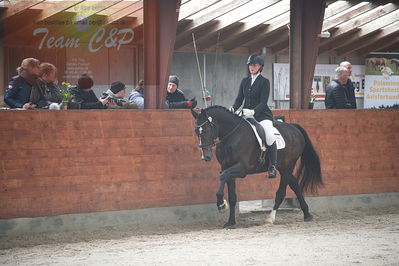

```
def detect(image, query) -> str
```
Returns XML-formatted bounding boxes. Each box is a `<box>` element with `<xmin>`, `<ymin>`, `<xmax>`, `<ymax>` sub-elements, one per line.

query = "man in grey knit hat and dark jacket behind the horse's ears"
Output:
<box><xmin>166</xmin><ymin>75</ymin><xmax>197</xmax><ymax>109</ymax></box>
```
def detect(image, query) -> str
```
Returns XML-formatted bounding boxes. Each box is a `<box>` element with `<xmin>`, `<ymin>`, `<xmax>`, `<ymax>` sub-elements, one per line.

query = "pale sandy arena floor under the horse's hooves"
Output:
<box><xmin>0</xmin><ymin>207</ymin><xmax>399</xmax><ymax>265</ymax></box>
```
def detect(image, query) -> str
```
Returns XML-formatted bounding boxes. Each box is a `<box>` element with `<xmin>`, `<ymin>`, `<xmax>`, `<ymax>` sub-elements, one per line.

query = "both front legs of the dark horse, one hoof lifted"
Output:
<box><xmin>216</xmin><ymin>163</ymin><xmax>246</xmax><ymax>227</ymax></box>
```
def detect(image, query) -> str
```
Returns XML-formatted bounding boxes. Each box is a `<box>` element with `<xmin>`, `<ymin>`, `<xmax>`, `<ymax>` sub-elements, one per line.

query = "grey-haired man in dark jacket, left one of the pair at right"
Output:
<box><xmin>325</xmin><ymin>66</ymin><xmax>353</xmax><ymax>109</ymax></box>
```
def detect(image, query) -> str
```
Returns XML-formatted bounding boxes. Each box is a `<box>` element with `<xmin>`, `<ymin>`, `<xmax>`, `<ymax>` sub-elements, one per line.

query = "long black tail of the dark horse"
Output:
<box><xmin>293</xmin><ymin>124</ymin><xmax>323</xmax><ymax>193</ymax></box>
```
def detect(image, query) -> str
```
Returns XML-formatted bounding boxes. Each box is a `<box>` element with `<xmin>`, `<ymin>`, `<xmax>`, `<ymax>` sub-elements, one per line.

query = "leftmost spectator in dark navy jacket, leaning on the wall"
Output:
<box><xmin>4</xmin><ymin>58</ymin><xmax>47</xmax><ymax>110</ymax></box>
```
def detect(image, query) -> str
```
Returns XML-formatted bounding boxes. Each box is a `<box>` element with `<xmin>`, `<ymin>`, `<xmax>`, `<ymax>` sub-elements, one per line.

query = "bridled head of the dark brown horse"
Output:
<box><xmin>191</xmin><ymin>110</ymin><xmax>219</xmax><ymax>162</ymax></box>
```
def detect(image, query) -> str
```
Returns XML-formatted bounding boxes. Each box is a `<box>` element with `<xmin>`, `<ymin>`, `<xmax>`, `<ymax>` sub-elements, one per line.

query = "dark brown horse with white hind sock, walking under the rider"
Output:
<box><xmin>192</xmin><ymin>106</ymin><xmax>323</xmax><ymax>228</ymax></box>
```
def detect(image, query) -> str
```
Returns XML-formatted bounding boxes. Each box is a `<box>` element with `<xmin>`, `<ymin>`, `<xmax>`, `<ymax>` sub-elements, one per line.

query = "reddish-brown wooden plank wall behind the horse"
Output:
<box><xmin>0</xmin><ymin>110</ymin><xmax>399</xmax><ymax>219</ymax></box>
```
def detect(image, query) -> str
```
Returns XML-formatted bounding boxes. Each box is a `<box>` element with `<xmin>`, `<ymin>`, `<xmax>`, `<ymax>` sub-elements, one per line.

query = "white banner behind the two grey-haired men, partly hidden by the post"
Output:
<box><xmin>273</xmin><ymin>63</ymin><xmax>365</xmax><ymax>100</ymax></box>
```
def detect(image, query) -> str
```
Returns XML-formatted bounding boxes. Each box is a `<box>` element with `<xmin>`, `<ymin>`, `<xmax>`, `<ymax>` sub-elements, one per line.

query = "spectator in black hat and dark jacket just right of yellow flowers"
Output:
<box><xmin>71</xmin><ymin>74</ymin><xmax>110</xmax><ymax>109</ymax></box>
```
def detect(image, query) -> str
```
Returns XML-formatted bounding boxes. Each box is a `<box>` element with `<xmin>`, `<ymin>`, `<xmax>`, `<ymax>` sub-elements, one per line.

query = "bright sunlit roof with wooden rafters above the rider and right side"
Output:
<box><xmin>175</xmin><ymin>0</ymin><xmax>399</xmax><ymax>56</ymax></box>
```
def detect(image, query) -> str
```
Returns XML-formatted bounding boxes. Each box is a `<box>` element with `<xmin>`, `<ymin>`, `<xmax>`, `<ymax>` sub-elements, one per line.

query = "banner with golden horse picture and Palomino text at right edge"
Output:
<box><xmin>364</xmin><ymin>53</ymin><xmax>399</xmax><ymax>109</ymax></box>
